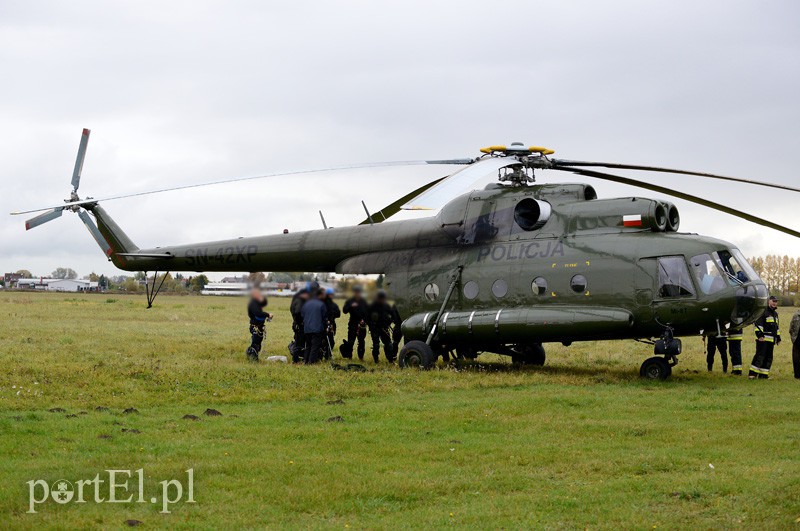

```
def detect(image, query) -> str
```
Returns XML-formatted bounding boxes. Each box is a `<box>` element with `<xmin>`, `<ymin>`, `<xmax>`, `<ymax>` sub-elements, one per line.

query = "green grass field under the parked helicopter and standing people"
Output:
<box><xmin>0</xmin><ymin>293</ymin><xmax>800</xmax><ymax>529</ymax></box>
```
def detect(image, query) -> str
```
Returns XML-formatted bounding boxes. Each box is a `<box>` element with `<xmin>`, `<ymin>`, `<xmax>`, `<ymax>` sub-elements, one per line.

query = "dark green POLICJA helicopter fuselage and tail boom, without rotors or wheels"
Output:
<box><xmin>90</xmin><ymin>184</ymin><xmax>767</xmax><ymax>358</ymax></box>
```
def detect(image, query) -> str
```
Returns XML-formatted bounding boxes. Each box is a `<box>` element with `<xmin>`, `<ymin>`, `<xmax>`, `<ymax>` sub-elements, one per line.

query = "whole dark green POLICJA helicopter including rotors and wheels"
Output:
<box><xmin>13</xmin><ymin>129</ymin><xmax>800</xmax><ymax>380</ymax></box>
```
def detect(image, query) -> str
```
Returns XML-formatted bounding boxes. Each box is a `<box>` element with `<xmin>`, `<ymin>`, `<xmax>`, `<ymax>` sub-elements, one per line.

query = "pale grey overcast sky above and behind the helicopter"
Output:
<box><xmin>0</xmin><ymin>0</ymin><xmax>800</xmax><ymax>282</ymax></box>
